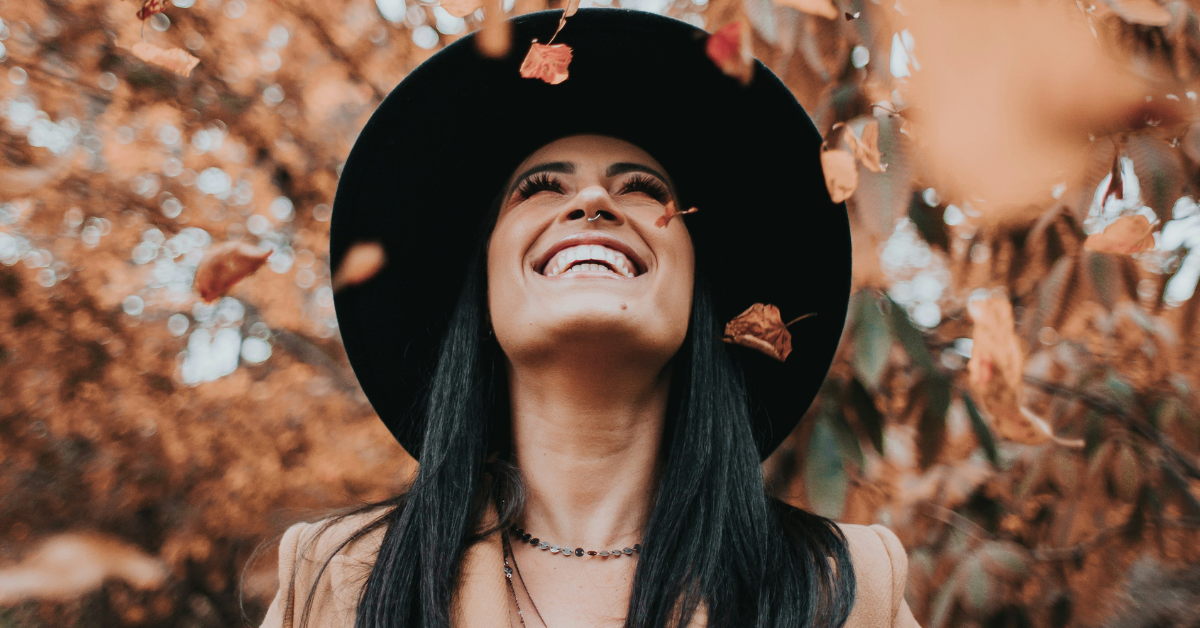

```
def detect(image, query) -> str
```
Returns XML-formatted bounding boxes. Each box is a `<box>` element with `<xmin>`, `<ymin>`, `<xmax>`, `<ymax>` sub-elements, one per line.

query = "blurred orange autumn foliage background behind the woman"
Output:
<box><xmin>0</xmin><ymin>0</ymin><xmax>1200</xmax><ymax>628</ymax></box>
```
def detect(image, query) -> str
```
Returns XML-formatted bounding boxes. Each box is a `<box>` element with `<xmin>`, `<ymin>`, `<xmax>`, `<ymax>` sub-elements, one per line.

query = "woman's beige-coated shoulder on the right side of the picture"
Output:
<box><xmin>838</xmin><ymin>524</ymin><xmax>917</xmax><ymax>628</ymax></box>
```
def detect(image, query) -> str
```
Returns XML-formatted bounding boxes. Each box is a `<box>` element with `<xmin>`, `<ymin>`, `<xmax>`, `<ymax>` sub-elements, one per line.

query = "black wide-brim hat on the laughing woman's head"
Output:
<box><xmin>330</xmin><ymin>8</ymin><xmax>851</xmax><ymax>459</ymax></box>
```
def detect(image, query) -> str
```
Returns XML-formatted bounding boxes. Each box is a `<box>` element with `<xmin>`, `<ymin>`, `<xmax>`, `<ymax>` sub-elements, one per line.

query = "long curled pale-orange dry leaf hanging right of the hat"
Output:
<box><xmin>967</xmin><ymin>294</ymin><xmax>1084</xmax><ymax>447</ymax></box>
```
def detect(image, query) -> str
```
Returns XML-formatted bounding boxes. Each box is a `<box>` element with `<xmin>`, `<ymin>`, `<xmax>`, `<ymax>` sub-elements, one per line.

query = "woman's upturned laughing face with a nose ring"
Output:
<box><xmin>487</xmin><ymin>136</ymin><xmax>695</xmax><ymax>366</ymax></box>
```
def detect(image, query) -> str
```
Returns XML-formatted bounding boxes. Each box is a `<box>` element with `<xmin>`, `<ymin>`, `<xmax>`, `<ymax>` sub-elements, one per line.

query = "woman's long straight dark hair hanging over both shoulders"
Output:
<box><xmin>292</xmin><ymin>194</ymin><xmax>854</xmax><ymax>628</ymax></box>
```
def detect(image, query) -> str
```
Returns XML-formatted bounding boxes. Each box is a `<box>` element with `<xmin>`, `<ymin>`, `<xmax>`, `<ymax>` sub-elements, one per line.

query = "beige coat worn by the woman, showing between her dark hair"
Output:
<box><xmin>263</xmin><ymin>515</ymin><xmax>919</xmax><ymax>628</ymax></box>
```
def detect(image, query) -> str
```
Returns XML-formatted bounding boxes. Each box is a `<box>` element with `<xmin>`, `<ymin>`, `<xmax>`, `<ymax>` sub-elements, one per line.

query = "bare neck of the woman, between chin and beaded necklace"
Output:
<box><xmin>509</xmin><ymin>354</ymin><xmax>671</xmax><ymax>550</ymax></box>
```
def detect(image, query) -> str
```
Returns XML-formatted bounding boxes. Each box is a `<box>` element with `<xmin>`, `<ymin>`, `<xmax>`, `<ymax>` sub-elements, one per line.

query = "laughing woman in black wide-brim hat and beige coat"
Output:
<box><xmin>263</xmin><ymin>10</ymin><xmax>916</xmax><ymax>628</ymax></box>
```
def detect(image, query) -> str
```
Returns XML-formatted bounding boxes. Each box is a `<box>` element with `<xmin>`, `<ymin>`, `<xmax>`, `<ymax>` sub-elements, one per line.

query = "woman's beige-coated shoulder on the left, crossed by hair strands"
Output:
<box><xmin>262</xmin><ymin>510</ymin><xmax>386</xmax><ymax>628</ymax></box>
